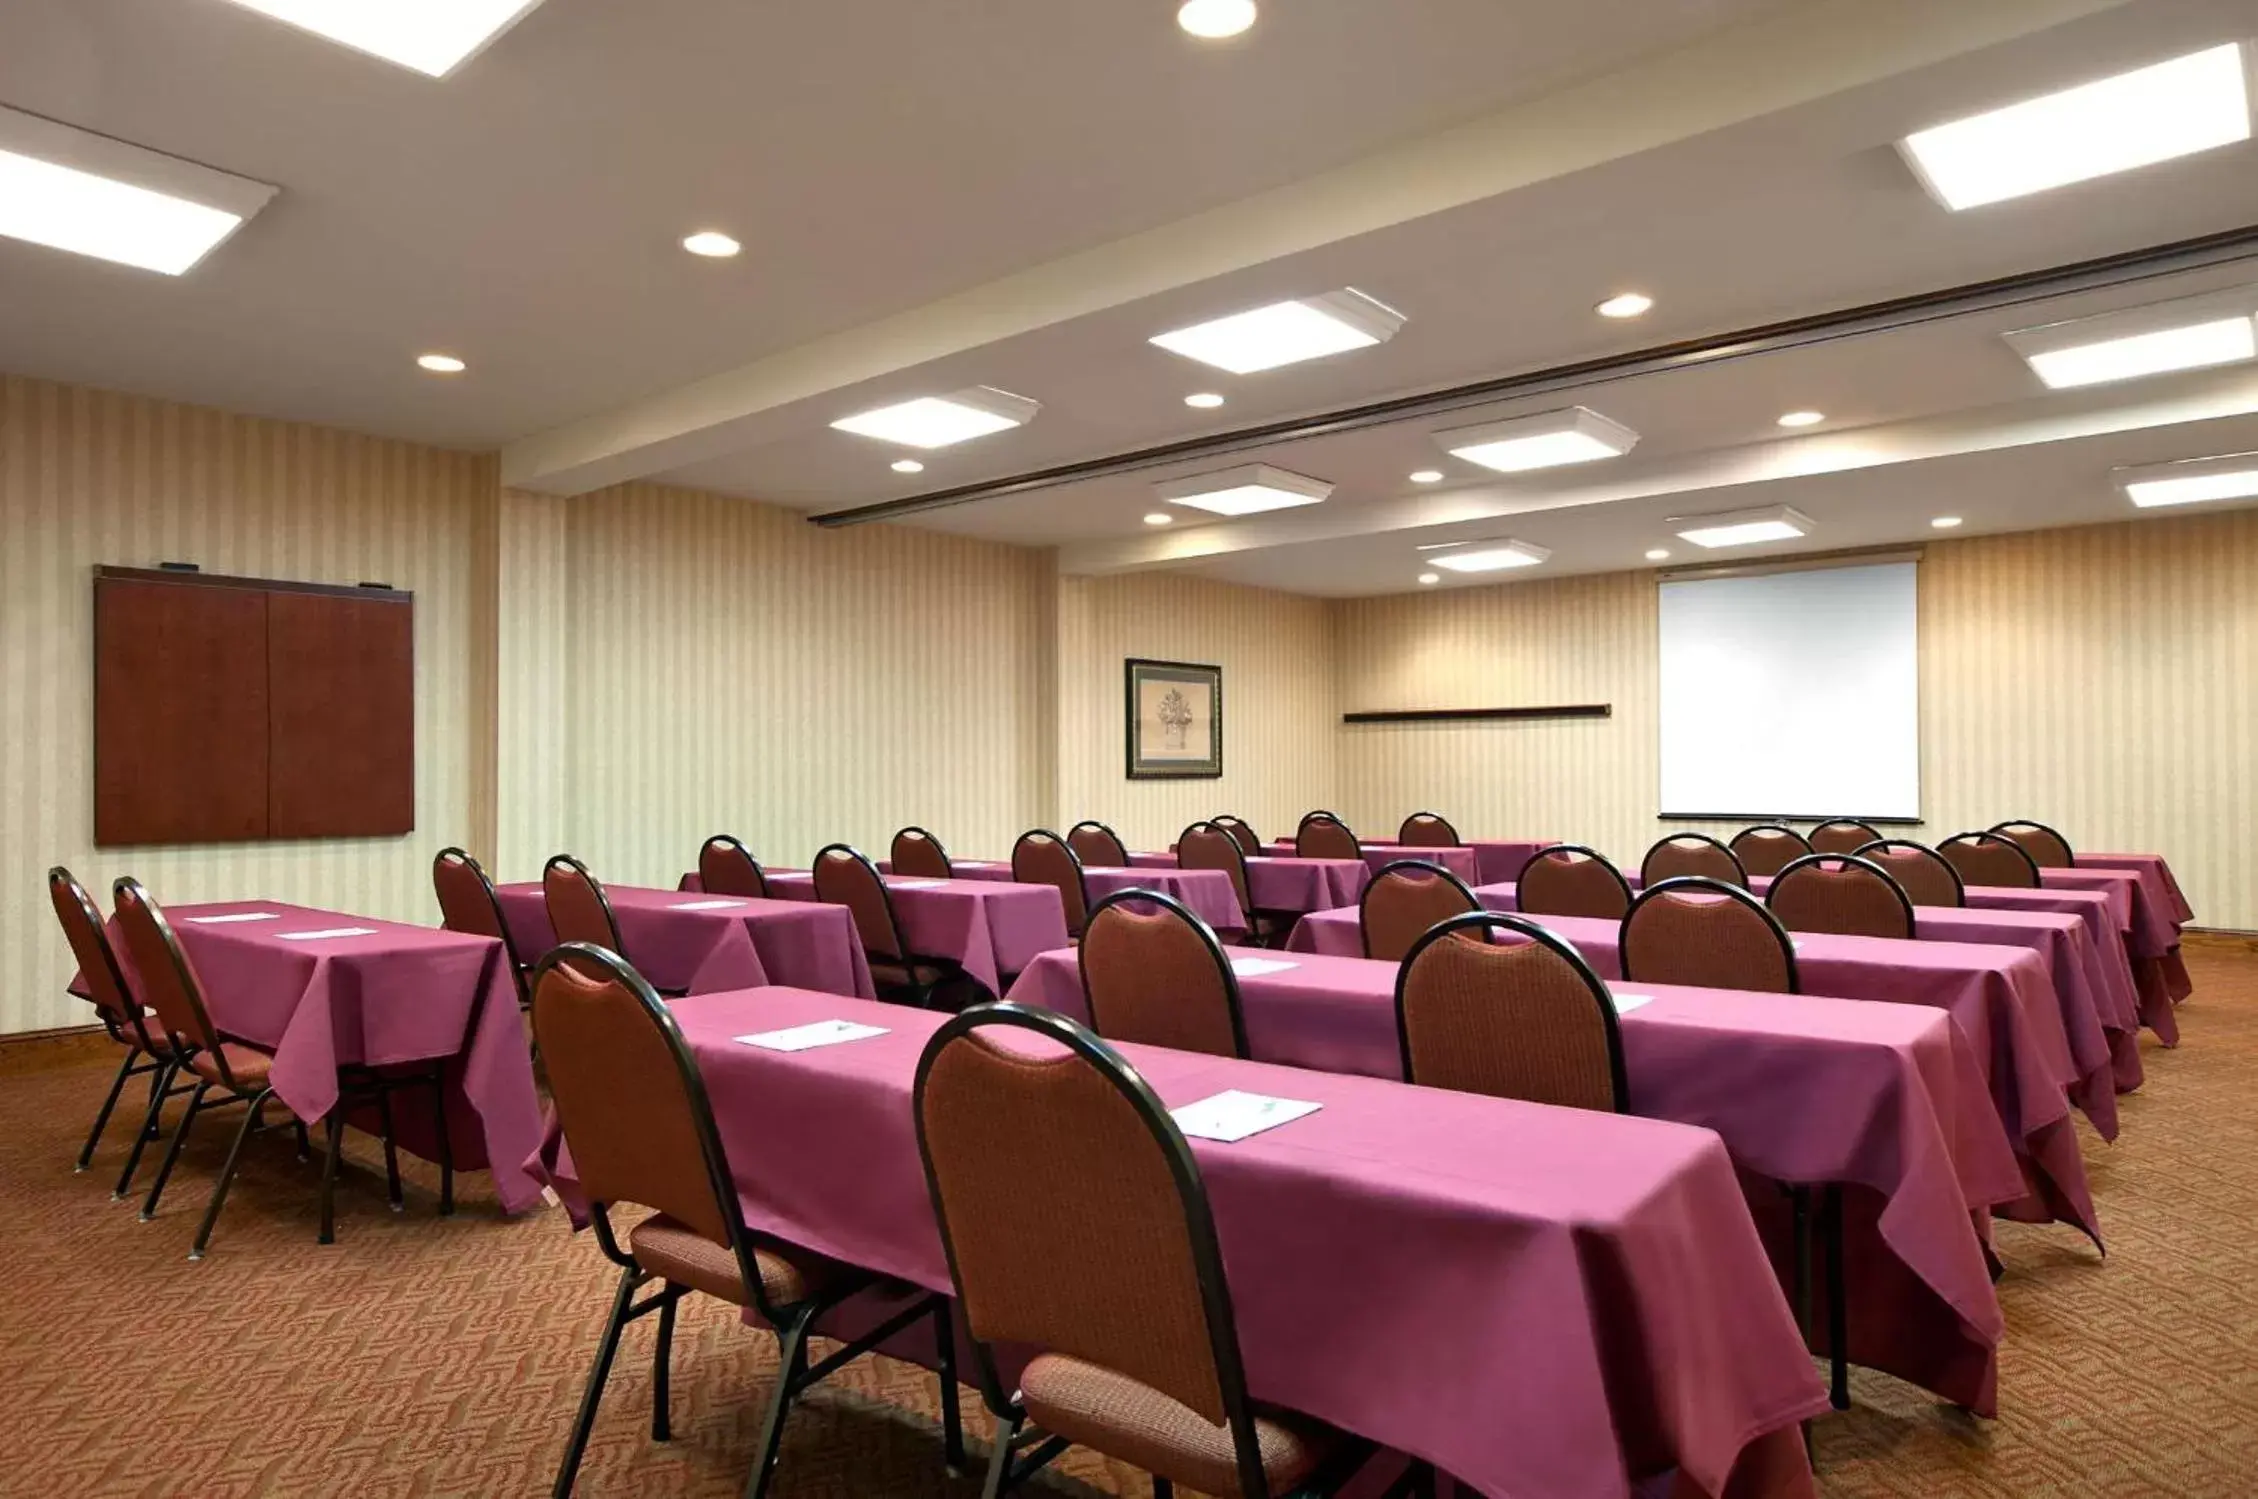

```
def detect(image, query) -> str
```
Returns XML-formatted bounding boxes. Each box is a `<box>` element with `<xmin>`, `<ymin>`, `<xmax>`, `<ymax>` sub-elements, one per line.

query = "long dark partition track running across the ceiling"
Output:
<box><xmin>808</xmin><ymin>223</ymin><xmax>2258</xmax><ymax>526</ymax></box>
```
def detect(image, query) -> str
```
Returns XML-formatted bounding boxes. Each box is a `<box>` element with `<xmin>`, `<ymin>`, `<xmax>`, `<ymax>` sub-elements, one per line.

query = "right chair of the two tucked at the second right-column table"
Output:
<box><xmin>1395</xmin><ymin>912</ymin><xmax>1630</xmax><ymax>1113</ymax></box>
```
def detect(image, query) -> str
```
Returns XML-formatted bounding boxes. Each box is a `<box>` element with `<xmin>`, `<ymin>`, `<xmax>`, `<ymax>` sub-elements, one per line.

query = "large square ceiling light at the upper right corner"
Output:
<box><xmin>1897</xmin><ymin>43</ymin><xmax>2251</xmax><ymax>210</ymax></box>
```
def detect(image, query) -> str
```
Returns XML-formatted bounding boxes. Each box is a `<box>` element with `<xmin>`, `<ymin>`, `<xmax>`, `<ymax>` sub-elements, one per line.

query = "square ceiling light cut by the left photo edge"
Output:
<box><xmin>0</xmin><ymin>108</ymin><xmax>275</xmax><ymax>275</ymax></box>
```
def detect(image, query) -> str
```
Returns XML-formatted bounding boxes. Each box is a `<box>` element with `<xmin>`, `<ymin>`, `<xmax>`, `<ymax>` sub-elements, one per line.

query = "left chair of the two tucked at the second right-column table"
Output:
<box><xmin>1079</xmin><ymin>889</ymin><xmax>1246</xmax><ymax>1057</ymax></box>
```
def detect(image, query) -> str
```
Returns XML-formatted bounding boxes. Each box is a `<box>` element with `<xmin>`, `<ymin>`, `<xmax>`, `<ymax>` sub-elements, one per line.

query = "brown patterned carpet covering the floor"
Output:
<box><xmin>0</xmin><ymin>944</ymin><xmax>2258</xmax><ymax>1499</ymax></box>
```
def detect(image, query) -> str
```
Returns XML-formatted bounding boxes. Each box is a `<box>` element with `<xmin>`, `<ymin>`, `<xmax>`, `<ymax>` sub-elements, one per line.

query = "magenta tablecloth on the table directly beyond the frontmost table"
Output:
<box><xmin>1012</xmin><ymin>953</ymin><xmax>2023</xmax><ymax>1415</ymax></box>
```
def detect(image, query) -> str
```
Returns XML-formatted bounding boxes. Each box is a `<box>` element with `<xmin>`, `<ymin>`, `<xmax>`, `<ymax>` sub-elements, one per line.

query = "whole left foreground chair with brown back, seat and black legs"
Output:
<box><xmin>533</xmin><ymin>944</ymin><xmax>962</xmax><ymax>1499</ymax></box>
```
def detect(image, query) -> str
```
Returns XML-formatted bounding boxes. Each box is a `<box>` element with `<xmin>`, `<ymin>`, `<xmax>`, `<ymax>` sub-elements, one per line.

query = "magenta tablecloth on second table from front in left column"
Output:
<box><xmin>495</xmin><ymin>885</ymin><xmax>878</xmax><ymax>1000</ymax></box>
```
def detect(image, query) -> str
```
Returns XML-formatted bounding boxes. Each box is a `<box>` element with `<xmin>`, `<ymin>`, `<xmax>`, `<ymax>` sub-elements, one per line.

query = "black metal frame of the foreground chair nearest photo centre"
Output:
<box><xmin>910</xmin><ymin>1006</ymin><xmax>1420</xmax><ymax>1499</ymax></box>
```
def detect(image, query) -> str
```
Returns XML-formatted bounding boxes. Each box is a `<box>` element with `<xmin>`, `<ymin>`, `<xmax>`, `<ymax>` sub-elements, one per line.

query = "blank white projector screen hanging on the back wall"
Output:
<box><xmin>1662</xmin><ymin>562</ymin><xmax>1922</xmax><ymax>819</ymax></box>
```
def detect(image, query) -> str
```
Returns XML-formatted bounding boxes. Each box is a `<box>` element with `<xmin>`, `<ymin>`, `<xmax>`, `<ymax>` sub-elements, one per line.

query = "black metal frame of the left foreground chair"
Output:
<box><xmin>533</xmin><ymin>941</ymin><xmax>964</xmax><ymax>1499</ymax></box>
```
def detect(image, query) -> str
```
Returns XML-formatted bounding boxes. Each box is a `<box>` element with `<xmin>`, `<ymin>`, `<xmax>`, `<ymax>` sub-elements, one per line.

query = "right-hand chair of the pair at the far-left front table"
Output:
<box><xmin>113</xmin><ymin>876</ymin><xmax>368</xmax><ymax>1260</ymax></box>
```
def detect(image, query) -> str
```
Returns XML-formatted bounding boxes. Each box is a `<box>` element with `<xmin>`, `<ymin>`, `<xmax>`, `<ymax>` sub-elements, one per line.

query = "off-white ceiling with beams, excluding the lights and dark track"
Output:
<box><xmin>0</xmin><ymin>0</ymin><xmax>2258</xmax><ymax>594</ymax></box>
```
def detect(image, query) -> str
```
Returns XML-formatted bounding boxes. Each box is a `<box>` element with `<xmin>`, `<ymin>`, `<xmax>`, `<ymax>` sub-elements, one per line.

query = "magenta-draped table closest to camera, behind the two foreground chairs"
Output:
<box><xmin>540</xmin><ymin>989</ymin><xmax>1827</xmax><ymax>1499</ymax></box>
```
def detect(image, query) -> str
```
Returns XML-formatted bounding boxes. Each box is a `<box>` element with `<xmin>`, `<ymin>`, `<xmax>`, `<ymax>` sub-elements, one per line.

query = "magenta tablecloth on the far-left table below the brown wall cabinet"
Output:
<box><xmin>115</xmin><ymin>901</ymin><xmax>542</xmax><ymax>1212</ymax></box>
